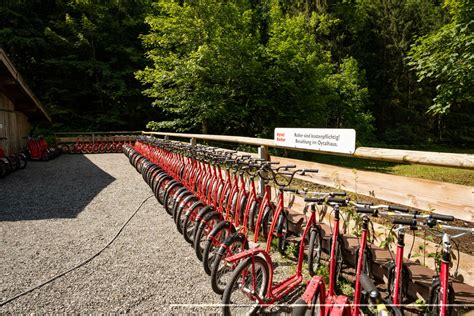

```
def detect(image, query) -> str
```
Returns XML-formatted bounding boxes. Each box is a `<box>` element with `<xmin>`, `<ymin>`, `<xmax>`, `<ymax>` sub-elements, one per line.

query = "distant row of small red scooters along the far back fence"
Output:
<box><xmin>61</xmin><ymin>136</ymin><xmax>134</xmax><ymax>154</ymax></box>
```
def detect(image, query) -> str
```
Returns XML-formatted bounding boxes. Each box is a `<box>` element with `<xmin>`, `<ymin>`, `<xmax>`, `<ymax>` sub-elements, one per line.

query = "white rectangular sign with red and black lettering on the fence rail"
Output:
<box><xmin>275</xmin><ymin>128</ymin><xmax>356</xmax><ymax>154</ymax></box>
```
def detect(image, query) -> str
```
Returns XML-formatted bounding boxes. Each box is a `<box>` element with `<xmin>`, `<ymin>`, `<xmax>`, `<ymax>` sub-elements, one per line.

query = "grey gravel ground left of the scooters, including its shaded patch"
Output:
<box><xmin>0</xmin><ymin>154</ymin><xmax>220</xmax><ymax>314</ymax></box>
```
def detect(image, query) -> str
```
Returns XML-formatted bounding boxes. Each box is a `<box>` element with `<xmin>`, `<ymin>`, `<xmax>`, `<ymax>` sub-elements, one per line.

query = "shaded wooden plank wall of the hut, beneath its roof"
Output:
<box><xmin>0</xmin><ymin>92</ymin><xmax>30</xmax><ymax>154</ymax></box>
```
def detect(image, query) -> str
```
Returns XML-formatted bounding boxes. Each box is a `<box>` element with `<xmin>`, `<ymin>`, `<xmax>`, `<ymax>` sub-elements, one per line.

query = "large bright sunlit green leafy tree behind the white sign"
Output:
<box><xmin>136</xmin><ymin>0</ymin><xmax>372</xmax><ymax>137</ymax></box>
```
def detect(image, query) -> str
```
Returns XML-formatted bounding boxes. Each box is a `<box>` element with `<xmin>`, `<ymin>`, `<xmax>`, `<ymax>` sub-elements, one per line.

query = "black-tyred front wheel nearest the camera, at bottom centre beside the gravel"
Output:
<box><xmin>222</xmin><ymin>257</ymin><xmax>269</xmax><ymax>315</ymax></box>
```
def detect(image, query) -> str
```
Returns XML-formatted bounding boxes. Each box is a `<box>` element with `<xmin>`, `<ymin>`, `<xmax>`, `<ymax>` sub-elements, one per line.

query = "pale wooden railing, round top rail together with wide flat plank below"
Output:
<box><xmin>143</xmin><ymin>132</ymin><xmax>474</xmax><ymax>222</ymax></box>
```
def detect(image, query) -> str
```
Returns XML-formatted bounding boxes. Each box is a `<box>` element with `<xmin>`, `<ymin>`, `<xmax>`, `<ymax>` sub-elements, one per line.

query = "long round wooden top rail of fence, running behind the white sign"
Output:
<box><xmin>142</xmin><ymin>132</ymin><xmax>474</xmax><ymax>169</ymax></box>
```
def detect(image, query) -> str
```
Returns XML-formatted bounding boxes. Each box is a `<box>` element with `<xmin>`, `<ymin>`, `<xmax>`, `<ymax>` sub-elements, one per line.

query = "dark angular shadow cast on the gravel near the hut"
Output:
<box><xmin>0</xmin><ymin>155</ymin><xmax>115</xmax><ymax>221</ymax></box>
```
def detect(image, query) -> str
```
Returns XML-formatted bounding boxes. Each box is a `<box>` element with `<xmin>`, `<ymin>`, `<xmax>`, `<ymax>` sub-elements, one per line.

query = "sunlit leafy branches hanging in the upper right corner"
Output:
<box><xmin>409</xmin><ymin>0</ymin><xmax>474</xmax><ymax>115</ymax></box>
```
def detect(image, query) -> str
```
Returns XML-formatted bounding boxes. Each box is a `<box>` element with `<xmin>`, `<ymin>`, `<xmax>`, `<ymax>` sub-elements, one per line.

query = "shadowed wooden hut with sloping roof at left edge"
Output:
<box><xmin>0</xmin><ymin>48</ymin><xmax>51</xmax><ymax>154</ymax></box>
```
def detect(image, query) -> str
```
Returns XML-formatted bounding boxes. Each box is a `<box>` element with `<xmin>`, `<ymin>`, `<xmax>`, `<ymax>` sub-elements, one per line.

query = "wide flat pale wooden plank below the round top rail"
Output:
<box><xmin>271</xmin><ymin>156</ymin><xmax>474</xmax><ymax>222</ymax></box>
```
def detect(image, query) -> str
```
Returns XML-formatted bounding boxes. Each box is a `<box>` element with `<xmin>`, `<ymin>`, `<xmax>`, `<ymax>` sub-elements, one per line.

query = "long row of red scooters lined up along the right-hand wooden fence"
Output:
<box><xmin>123</xmin><ymin>137</ymin><xmax>473</xmax><ymax>315</ymax></box>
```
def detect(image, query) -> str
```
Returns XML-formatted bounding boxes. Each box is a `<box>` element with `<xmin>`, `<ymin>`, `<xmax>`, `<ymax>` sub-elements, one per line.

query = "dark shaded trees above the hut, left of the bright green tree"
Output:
<box><xmin>0</xmin><ymin>0</ymin><xmax>150</xmax><ymax>130</ymax></box>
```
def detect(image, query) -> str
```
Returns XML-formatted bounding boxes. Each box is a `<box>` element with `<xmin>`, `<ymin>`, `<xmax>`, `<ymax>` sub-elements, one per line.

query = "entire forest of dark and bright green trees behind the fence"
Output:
<box><xmin>0</xmin><ymin>0</ymin><xmax>474</xmax><ymax>148</ymax></box>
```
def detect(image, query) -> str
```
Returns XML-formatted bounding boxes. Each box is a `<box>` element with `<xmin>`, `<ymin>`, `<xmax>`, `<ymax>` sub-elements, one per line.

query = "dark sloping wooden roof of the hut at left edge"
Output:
<box><xmin>0</xmin><ymin>48</ymin><xmax>51</xmax><ymax>122</ymax></box>
